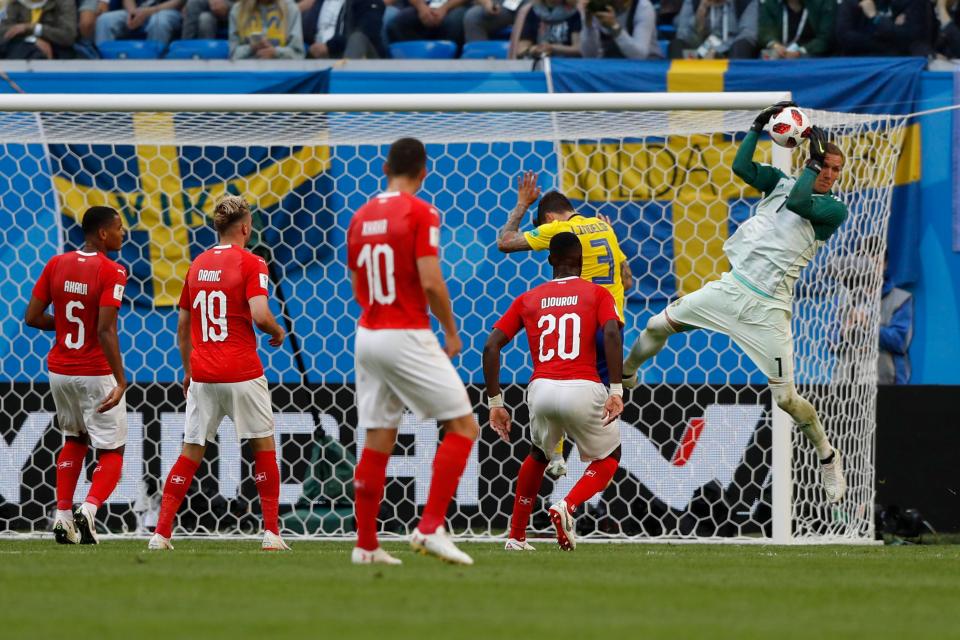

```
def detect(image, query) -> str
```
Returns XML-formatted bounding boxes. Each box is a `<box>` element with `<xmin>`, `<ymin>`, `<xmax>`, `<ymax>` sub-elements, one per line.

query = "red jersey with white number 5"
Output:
<box><xmin>33</xmin><ymin>251</ymin><xmax>127</xmax><ymax>376</ymax></box>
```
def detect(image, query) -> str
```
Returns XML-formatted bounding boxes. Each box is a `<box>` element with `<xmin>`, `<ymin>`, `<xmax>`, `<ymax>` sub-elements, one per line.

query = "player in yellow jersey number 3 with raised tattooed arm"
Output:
<box><xmin>497</xmin><ymin>171</ymin><xmax>633</xmax><ymax>477</ymax></box>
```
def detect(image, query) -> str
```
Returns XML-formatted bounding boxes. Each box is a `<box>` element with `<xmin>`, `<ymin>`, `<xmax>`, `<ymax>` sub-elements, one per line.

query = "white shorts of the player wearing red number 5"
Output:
<box><xmin>50</xmin><ymin>372</ymin><xmax>127</xmax><ymax>449</ymax></box>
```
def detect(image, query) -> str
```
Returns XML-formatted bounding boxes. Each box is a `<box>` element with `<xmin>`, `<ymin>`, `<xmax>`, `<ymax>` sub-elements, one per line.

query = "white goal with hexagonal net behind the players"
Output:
<box><xmin>0</xmin><ymin>94</ymin><xmax>904</xmax><ymax>542</ymax></box>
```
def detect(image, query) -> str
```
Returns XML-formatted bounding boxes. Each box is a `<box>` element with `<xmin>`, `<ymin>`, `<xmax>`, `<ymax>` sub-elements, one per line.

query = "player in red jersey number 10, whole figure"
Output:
<box><xmin>347</xmin><ymin>138</ymin><xmax>479</xmax><ymax>564</ymax></box>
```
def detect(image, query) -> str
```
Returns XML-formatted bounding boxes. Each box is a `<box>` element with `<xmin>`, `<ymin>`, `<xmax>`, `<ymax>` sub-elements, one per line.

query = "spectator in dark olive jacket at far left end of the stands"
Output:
<box><xmin>0</xmin><ymin>0</ymin><xmax>77</xmax><ymax>60</ymax></box>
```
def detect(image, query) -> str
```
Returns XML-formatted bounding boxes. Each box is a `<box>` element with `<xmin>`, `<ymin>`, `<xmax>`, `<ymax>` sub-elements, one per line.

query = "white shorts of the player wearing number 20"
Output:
<box><xmin>527</xmin><ymin>378</ymin><xmax>620</xmax><ymax>462</ymax></box>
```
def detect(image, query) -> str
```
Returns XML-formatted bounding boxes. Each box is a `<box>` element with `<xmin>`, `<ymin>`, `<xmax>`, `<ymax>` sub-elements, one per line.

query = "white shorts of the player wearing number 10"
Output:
<box><xmin>354</xmin><ymin>327</ymin><xmax>473</xmax><ymax>429</ymax></box>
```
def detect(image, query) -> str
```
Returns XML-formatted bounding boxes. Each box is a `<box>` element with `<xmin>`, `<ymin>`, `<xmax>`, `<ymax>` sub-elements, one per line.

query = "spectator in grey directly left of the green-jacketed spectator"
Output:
<box><xmin>670</xmin><ymin>0</ymin><xmax>758</xmax><ymax>59</ymax></box>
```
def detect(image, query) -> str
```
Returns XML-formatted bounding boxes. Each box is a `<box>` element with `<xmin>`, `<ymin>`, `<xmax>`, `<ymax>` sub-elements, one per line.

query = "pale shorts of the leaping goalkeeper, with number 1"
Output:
<box><xmin>666</xmin><ymin>272</ymin><xmax>793</xmax><ymax>384</ymax></box>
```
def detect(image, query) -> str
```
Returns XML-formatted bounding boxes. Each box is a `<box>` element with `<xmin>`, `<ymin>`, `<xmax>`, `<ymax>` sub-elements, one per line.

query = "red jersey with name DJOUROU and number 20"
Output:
<box><xmin>493</xmin><ymin>277</ymin><xmax>620</xmax><ymax>382</ymax></box>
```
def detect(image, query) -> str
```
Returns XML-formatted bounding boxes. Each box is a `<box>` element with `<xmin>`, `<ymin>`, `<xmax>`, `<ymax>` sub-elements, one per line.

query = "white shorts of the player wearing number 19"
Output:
<box><xmin>183</xmin><ymin>376</ymin><xmax>273</xmax><ymax>444</ymax></box>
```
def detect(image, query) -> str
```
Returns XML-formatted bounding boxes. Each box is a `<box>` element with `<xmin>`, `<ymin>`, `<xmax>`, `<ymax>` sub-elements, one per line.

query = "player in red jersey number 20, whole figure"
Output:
<box><xmin>483</xmin><ymin>232</ymin><xmax>623</xmax><ymax>551</ymax></box>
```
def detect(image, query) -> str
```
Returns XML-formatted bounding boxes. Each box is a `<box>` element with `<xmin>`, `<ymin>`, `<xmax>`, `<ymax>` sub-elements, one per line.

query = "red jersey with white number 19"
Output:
<box><xmin>180</xmin><ymin>244</ymin><xmax>270</xmax><ymax>382</ymax></box>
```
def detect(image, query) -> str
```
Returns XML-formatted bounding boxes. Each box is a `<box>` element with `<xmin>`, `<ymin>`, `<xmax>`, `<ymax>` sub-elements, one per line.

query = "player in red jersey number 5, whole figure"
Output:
<box><xmin>24</xmin><ymin>207</ymin><xmax>127</xmax><ymax>544</ymax></box>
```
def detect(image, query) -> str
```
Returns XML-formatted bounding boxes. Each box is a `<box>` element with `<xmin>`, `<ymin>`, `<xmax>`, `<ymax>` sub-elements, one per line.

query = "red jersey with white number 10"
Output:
<box><xmin>347</xmin><ymin>191</ymin><xmax>440</xmax><ymax>329</ymax></box>
